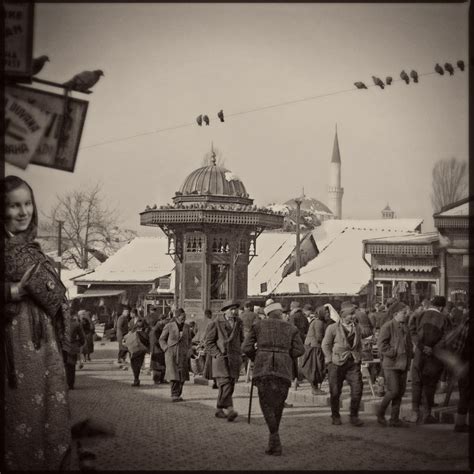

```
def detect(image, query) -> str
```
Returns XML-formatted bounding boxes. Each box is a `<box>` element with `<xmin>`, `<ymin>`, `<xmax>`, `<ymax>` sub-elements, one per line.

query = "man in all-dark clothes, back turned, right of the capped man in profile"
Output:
<box><xmin>406</xmin><ymin>296</ymin><xmax>449</xmax><ymax>424</ymax></box>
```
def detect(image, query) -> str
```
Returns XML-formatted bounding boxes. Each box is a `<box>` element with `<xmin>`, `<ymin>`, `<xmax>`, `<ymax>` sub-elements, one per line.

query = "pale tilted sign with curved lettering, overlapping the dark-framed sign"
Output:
<box><xmin>4</xmin><ymin>93</ymin><xmax>49</xmax><ymax>169</ymax></box>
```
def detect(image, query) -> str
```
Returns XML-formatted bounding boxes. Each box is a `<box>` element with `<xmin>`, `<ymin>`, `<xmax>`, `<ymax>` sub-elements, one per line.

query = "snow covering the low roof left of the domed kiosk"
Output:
<box><xmin>74</xmin><ymin>236</ymin><xmax>174</xmax><ymax>283</ymax></box>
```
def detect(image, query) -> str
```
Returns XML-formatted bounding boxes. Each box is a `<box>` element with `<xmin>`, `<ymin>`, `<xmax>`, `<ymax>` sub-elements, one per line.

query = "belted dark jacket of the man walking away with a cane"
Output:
<box><xmin>242</xmin><ymin>316</ymin><xmax>304</xmax><ymax>382</ymax></box>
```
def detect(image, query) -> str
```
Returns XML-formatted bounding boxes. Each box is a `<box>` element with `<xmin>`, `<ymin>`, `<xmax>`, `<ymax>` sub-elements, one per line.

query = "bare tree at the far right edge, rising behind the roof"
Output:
<box><xmin>431</xmin><ymin>158</ymin><xmax>468</xmax><ymax>212</ymax></box>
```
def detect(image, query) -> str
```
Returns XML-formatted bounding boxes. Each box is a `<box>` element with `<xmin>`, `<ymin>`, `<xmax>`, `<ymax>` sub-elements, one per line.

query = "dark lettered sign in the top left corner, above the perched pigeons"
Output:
<box><xmin>3</xmin><ymin>2</ymin><xmax>34</xmax><ymax>82</ymax></box>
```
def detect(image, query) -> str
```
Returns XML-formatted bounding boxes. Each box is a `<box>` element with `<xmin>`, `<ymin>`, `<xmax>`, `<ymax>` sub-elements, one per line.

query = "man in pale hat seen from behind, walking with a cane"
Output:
<box><xmin>242</xmin><ymin>302</ymin><xmax>304</xmax><ymax>456</ymax></box>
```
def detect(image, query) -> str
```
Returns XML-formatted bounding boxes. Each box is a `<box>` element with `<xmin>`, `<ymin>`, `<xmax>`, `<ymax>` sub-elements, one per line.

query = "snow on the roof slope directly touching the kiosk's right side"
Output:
<box><xmin>248</xmin><ymin>232</ymin><xmax>296</xmax><ymax>295</ymax></box>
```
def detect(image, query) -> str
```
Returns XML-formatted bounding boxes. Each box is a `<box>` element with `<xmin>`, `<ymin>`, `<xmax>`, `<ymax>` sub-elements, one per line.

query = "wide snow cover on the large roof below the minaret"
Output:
<box><xmin>270</xmin><ymin>219</ymin><xmax>423</xmax><ymax>295</ymax></box>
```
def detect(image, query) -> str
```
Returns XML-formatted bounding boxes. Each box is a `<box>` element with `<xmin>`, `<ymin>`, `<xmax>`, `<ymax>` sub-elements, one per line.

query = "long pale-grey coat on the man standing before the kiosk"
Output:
<box><xmin>159</xmin><ymin>318</ymin><xmax>193</xmax><ymax>382</ymax></box>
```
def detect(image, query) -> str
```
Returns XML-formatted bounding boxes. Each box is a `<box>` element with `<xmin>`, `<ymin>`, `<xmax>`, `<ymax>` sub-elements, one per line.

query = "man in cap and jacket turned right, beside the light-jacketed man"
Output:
<box><xmin>377</xmin><ymin>302</ymin><xmax>413</xmax><ymax>428</ymax></box>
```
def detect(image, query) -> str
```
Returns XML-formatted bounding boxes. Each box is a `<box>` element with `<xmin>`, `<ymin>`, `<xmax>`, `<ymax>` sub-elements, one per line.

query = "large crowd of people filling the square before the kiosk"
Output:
<box><xmin>110</xmin><ymin>296</ymin><xmax>469</xmax><ymax>455</ymax></box>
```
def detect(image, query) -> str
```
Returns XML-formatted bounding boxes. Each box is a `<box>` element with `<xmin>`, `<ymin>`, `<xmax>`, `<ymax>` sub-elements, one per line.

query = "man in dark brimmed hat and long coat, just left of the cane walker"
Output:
<box><xmin>204</xmin><ymin>301</ymin><xmax>243</xmax><ymax>421</ymax></box>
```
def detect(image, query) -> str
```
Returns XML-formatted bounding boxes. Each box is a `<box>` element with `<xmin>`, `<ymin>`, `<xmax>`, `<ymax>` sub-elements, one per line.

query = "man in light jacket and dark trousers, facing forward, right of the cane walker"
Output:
<box><xmin>321</xmin><ymin>302</ymin><xmax>367</xmax><ymax>426</ymax></box>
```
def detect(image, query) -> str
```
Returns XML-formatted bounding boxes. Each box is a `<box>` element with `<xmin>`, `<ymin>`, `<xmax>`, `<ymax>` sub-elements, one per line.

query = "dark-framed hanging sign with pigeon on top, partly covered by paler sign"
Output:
<box><xmin>5</xmin><ymin>85</ymin><xmax>89</xmax><ymax>172</ymax></box>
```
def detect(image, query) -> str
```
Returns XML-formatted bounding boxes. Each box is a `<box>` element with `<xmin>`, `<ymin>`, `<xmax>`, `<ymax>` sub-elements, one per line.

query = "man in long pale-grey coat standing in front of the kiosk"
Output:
<box><xmin>159</xmin><ymin>308</ymin><xmax>194</xmax><ymax>402</ymax></box>
